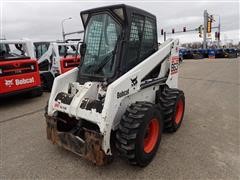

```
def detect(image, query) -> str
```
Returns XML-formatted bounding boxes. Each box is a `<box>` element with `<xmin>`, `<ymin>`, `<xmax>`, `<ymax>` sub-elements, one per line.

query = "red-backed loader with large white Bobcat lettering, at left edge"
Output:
<box><xmin>0</xmin><ymin>40</ymin><xmax>42</xmax><ymax>98</ymax></box>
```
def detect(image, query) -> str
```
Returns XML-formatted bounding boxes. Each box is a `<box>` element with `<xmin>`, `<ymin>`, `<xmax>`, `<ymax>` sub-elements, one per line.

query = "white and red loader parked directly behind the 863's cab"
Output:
<box><xmin>32</xmin><ymin>41</ymin><xmax>80</xmax><ymax>91</ymax></box>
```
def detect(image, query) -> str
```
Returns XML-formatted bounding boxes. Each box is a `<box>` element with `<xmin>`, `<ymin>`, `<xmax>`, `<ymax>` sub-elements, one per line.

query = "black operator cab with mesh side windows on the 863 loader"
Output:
<box><xmin>78</xmin><ymin>4</ymin><xmax>158</xmax><ymax>84</ymax></box>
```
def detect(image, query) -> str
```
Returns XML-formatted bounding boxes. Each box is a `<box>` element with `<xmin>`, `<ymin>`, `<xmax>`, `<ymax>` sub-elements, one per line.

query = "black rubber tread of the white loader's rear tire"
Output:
<box><xmin>159</xmin><ymin>86</ymin><xmax>183</xmax><ymax>132</ymax></box>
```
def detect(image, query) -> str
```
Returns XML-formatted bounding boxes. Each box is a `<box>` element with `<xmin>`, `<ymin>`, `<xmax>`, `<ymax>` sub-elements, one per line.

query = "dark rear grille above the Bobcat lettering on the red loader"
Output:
<box><xmin>0</xmin><ymin>63</ymin><xmax>36</xmax><ymax>77</ymax></box>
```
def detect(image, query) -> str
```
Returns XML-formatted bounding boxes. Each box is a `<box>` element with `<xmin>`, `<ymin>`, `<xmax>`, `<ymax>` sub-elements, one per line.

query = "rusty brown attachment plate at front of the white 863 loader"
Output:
<box><xmin>45</xmin><ymin>115</ymin><xmax>111</xmax><ymax>165</ymax></box>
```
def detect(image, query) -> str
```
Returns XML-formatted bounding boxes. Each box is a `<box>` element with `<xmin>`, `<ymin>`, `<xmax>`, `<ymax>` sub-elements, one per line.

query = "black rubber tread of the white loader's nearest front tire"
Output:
<box><xmin>116</xmin><ymin>102</ymin><xmax>153</xmax><ymax>165</ymax></box>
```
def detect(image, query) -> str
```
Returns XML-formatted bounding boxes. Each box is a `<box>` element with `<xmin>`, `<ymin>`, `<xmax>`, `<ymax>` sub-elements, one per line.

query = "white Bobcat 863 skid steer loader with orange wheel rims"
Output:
<box><xmin>45</xmin><ymin>4</ymin><xmax>185</xmax><ymax>167</ymax></box>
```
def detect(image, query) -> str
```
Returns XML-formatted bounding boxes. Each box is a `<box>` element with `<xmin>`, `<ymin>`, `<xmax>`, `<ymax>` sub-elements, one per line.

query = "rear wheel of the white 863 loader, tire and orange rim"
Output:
<box><xmin>159</xmin><ymin>86</ymin><xmax>185</xmax><ymax>132</ymax></box>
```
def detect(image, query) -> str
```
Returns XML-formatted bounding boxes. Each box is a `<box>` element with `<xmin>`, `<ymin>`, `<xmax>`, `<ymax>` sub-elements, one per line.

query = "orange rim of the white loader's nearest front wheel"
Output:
<box><xmin>144</xmin><ymin>118</ymin><xmax>159</xmax><ymax>153</ymax></box>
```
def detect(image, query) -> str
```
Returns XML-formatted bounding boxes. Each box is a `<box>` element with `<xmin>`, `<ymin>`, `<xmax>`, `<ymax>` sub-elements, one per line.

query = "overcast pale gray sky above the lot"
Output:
<box><xmin>0</xmin><ymin>0</ymin><xmax>240</xmax><ymax>42</ymax></box>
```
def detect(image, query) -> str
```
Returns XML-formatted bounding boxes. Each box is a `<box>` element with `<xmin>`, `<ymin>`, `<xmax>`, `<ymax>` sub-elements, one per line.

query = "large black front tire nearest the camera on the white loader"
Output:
<box><xmin>116</xmin><ymin>102</ymin><xmax>163</xmax><ymax>167</ymax></box>
